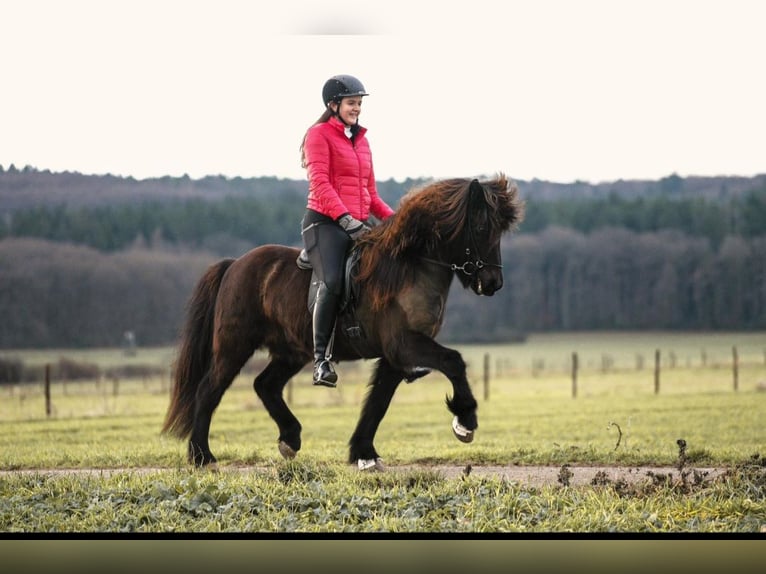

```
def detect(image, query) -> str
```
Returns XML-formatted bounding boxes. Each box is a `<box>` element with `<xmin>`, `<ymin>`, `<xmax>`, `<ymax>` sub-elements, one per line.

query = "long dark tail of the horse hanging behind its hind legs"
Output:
<box><xmin>162</xmin><ymin>259</ymin><xmax>234</xmax><ymax>439</ymax></box>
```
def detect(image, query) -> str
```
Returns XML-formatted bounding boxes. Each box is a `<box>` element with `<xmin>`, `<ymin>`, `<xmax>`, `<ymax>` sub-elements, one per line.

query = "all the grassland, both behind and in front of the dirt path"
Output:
<box><xmin>0</xmin><ymin>333</ymin><xmax>766</xmax><ymax>533</ymax></box>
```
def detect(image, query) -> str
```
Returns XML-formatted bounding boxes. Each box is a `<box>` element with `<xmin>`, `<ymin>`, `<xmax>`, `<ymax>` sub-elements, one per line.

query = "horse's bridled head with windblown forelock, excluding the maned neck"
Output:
<box><xmin>445</xmin><ymin>175</ymin><xmax>523</xmax><ymax>296</ymax></box>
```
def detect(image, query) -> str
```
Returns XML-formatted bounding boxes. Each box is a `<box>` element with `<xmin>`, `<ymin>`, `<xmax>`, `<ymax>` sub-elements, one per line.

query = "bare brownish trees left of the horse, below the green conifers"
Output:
<box><xmin>0</xmin><ymin>239</ymin><xmax>214</xmax><ymax>349</ymax></box>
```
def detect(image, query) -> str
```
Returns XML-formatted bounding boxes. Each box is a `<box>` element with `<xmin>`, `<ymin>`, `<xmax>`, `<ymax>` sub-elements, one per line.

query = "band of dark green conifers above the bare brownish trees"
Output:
<box><xmin>6</xmin><ymin>187</ymin><xmax>766</xmax><ymax>255</ymax></box>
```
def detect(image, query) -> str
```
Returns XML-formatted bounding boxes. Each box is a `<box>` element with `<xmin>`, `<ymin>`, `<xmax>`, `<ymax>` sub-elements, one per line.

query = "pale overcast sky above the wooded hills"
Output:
<box><xmin>0</xmin><ymin>0</ymin><xmax>766</xmax><ymax>183</ymax></box>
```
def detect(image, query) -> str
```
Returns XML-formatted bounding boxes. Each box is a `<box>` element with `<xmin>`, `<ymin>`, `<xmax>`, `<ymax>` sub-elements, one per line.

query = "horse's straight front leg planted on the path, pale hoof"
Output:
<box><xmin>348</xmin><ymin>359</ymin><xmax>403</xmax><ymax>470</ymax></box>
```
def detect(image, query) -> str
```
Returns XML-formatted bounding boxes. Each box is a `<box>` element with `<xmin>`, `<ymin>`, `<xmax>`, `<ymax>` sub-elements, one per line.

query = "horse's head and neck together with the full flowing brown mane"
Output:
<box><xmin>358</xmin><ymin>174</ymin><xmax>524</xmax><ymax>309</ymax></box>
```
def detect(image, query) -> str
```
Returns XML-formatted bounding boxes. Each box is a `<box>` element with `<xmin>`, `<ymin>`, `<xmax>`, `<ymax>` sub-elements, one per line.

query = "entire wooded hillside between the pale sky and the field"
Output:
<box><xmin>0</xmin><ymin>166</ymin><xmax>766</xmax><ymax>349</ymax></box>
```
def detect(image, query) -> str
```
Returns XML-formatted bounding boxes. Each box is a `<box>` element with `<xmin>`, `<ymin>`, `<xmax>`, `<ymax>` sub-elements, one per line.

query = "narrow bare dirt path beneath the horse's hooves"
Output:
<box><xmin>0</xmin><ymin>465</ymin><xmax>727</xmax><ymax>487</ymax></box>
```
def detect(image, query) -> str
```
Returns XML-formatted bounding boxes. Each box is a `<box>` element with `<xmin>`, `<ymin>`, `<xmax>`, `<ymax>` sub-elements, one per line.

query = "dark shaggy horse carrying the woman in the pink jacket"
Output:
<box><xmin>162</xmin><ymin>174</ymin><xmax>523</xmax><ymax>469</ymax></box>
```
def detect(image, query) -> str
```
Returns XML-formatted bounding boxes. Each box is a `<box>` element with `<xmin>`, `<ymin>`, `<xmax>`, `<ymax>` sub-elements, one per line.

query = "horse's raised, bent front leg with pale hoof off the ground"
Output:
<box><xmin>397</xmin><ymin>333</ymin><xmax>479</xmax><ymax>442</ymax></box>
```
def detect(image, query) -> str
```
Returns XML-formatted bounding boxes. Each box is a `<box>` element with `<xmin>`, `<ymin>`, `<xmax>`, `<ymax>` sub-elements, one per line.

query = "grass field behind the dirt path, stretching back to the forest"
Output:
<box><xmin>0</xmin><ymin>334</ymin><xmax>766</xmax><ymax>469</ymax></box>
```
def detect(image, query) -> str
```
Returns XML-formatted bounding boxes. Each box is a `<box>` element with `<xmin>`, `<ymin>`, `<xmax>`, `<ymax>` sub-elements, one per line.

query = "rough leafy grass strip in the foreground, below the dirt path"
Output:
<box><xmin>0</xmin><ymin>461</ymin><xmax>766</xmax><ymax>534</ymax></box>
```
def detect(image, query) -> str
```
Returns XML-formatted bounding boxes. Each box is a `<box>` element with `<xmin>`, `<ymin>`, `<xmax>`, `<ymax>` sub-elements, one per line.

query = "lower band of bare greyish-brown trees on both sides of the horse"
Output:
<box><xmin>0</xmin><ymin>227</ymin><xmax>766</xmax><ymax>348</ymax></box>
